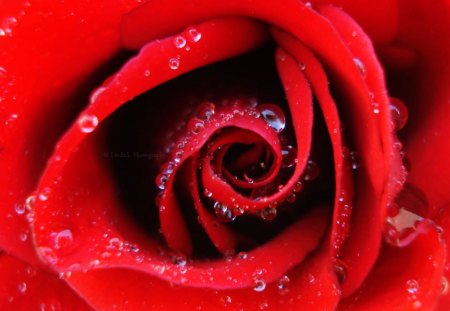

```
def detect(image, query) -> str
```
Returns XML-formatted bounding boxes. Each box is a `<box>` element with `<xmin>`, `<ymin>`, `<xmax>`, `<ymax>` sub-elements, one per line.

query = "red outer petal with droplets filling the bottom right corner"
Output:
<box><xmin>339</xmin><ymin>223</ymin><xmax>445</xmax><ymax>310</ymax></box>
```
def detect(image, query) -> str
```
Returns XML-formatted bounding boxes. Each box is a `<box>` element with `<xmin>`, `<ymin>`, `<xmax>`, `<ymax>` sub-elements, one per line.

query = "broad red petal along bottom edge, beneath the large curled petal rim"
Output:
<box><xmin>65</xmin><ymin>246</ymin><xmax>339</xmax><ymax>311</ymax></box>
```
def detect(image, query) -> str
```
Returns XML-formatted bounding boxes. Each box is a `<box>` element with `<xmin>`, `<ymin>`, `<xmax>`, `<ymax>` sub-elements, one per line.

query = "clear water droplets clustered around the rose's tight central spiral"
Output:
<box><xmin>155</xmin><ymin>97</ymin><xmax>319</xmax><ymax>232</ymax></box>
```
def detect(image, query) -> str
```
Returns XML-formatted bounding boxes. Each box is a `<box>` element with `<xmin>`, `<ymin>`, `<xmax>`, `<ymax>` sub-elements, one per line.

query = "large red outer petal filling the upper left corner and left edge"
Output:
<box><xmin>0</xmin><ymin>1</ymin><xmax>133</xmax><ymax>261</ymax></box>
